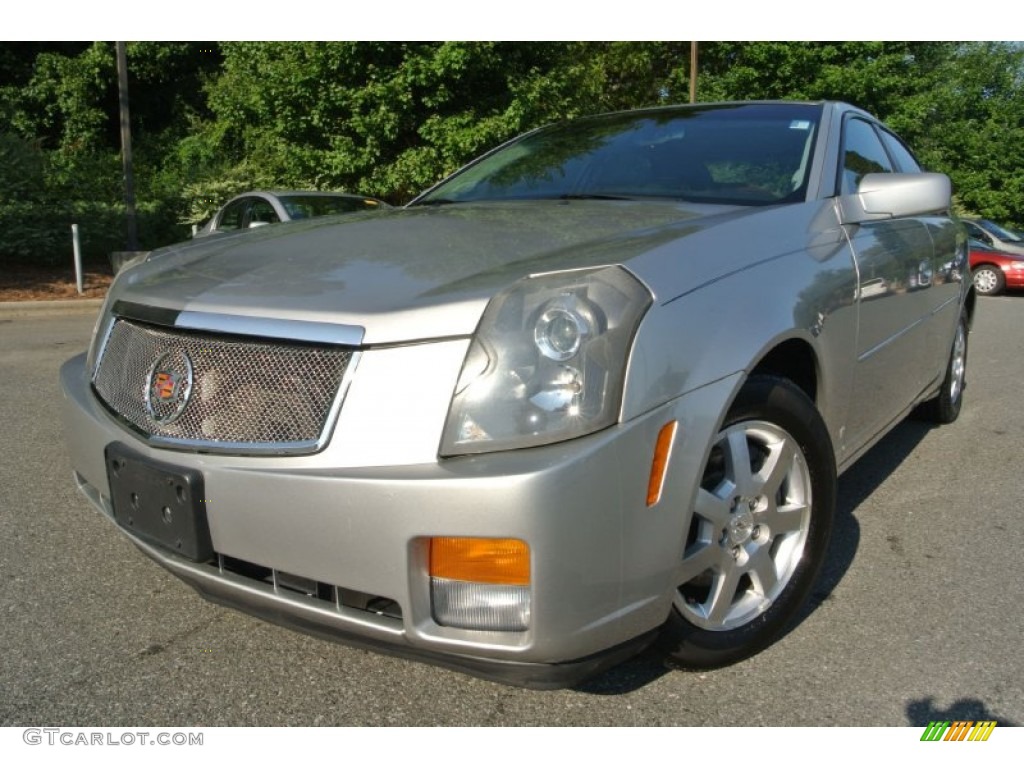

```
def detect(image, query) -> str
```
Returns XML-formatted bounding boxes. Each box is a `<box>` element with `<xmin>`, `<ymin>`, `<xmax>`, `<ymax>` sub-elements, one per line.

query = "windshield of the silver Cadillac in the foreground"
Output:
<box><xmin>416</xmin><ymin>103</ymin><xmax>821</xmax><ymax>205</ymax></box>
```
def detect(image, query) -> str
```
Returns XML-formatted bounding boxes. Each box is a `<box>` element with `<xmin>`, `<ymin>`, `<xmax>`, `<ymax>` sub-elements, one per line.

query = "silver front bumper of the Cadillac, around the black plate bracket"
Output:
<box><xmin>61</xmin><ymin>355</ymin><xmax>732</xmax><ymax>687</ymax></box>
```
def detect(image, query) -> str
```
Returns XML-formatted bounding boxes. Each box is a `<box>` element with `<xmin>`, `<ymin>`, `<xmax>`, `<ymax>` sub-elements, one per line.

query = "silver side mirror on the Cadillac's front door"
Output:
<box><xmin>840</xmin><ymin>173</ymin><xmax>952</xmax><ymax>224</ymax></box>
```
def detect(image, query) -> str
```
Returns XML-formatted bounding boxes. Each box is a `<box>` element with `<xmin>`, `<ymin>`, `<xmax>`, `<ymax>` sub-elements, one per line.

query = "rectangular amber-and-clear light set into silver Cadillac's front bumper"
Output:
<box><xmin>429</xmin><ymin>537</ymin><xmax>530</xmax><ymax>632</ymax></box>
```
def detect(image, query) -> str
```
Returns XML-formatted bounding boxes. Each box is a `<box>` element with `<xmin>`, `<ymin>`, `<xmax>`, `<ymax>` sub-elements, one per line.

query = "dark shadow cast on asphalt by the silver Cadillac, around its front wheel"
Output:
<box><xmin>573</xmin><ymin>419</ymin><xmax>935</xmax><ymax>695</ymax></box>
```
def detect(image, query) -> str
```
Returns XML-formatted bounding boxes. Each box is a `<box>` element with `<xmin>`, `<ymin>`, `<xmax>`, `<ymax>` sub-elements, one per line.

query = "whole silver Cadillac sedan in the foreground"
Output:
<box><xmin>61</xmin><ymin>102</ymin><xmax>975</xmax><ymax>687</ymax></box>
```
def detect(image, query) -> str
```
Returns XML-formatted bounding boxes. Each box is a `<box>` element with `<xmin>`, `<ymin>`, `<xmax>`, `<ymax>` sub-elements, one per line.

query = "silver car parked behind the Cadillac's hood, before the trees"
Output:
<box><xmin>196</xmin><ymin>190</ymin><xmax>390</xmax><ymax>238</ymax></box>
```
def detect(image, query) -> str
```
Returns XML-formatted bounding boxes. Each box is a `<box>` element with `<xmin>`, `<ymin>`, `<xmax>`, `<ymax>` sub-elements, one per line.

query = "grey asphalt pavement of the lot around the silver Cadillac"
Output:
<box><xmin>0</xmin><ymin>296</ymin><xmax>1024</xmax><ymax>729</ymax></box>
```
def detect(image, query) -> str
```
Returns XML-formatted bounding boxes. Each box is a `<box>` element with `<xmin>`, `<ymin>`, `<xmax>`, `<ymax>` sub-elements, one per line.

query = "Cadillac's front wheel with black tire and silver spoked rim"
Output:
<box><xmin>660</xmin><ymin>376</ymin><xmax>836</xmax><ymax>669</ymax></box>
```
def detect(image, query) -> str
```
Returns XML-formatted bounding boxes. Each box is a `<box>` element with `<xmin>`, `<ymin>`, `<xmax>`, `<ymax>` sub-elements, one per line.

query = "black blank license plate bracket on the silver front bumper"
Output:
<box><xmin>103</xmin><ymin>442</ymin><xmax>214</xmax><ymax>562</ymax></box>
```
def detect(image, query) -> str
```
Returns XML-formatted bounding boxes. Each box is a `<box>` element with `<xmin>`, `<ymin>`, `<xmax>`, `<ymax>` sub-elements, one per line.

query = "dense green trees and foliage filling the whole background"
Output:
<box><xmin>0</xmin><ymin>42</ymin><xmax>1024</xmax><ymax>260</ymax></box>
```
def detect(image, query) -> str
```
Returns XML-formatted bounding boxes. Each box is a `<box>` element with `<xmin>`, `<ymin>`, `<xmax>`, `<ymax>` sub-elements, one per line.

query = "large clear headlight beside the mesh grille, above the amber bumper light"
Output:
<box><xmin>440</xmin><ymin>266</ymin><xmax>651</xmax><ymax>456</ymax></box>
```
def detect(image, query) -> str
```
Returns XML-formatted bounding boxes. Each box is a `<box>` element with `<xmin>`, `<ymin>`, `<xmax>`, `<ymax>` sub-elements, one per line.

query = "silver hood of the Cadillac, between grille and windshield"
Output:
<box><xmin>112</xmin><ymin>201</ymin><xmax>765</xmax><ymax>344</ymax></box>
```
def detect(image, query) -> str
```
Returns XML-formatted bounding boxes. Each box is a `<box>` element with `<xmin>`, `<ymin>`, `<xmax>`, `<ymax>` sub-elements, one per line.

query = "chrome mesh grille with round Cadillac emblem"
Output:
<box><xmin>93</xmin><ymin>318</ymin><xmax>352</xmax><ymax>453</ymax></box>
